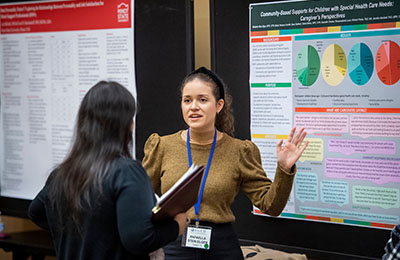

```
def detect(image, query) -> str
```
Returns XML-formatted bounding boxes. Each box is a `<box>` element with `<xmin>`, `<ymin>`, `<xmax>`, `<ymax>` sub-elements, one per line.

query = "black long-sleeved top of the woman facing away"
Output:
<box><xmin>28</xmin><ymin>158</ymin><xmax>179</xmax><ymax>260</ymax></box>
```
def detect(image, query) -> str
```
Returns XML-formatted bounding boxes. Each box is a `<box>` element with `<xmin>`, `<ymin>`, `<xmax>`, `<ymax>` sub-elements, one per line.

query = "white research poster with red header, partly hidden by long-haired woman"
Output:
<box><xmin>0</xmin><ymin>0</ymin><xmax>136</xmax><ymax>199</ymax></box>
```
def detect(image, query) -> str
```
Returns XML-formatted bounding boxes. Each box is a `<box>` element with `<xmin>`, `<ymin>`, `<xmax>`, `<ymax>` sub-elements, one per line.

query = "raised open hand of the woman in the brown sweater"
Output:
<box><xmin>276</xmin><ymin>127</ymin><xmax>308</xmax><ymax>172</ymax></box>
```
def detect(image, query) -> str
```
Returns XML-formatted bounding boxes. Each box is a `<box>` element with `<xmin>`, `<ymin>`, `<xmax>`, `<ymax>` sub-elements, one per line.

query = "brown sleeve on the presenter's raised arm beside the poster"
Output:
<box><xmin>239</xmin><ymin>140</ymin><xmax>296</xmax><ymax>216</ymax></box>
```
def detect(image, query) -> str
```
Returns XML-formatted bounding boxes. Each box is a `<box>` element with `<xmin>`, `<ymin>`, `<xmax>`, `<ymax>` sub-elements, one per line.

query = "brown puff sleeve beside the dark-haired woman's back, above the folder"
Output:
<box><xmin>142</xmin><ymin>133</ymin><xmax>162</xmax><ymax>191</ymax></box>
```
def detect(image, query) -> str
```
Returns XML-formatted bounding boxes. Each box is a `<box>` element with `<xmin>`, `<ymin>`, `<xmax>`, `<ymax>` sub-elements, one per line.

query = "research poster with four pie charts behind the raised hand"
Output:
<box><xmin>249</xmin><ymin>0</ymin><xmax>400</xmax><ymax>229</ymax></box>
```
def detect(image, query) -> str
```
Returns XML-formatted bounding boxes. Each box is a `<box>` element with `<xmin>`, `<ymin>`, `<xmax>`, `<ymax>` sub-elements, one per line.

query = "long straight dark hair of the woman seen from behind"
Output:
<box><xmin>48</xmin><ymin>81</ymin><xmax>136</xmax><ymax>230</ymax></box>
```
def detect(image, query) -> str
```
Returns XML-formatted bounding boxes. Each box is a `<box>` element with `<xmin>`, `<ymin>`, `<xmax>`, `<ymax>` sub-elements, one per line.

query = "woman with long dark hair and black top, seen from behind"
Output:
<box><xmin>29</xmin><ymin>81</ymin><xmax>186</xmax><ymax>260</ymax></box>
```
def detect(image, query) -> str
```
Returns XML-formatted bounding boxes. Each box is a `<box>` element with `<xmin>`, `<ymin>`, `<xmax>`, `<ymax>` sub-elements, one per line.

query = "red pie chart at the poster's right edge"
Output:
<box><xmin>375</xmin><ymin>41</ymin><xmax>400</xmax><ymax>85</ymax></box>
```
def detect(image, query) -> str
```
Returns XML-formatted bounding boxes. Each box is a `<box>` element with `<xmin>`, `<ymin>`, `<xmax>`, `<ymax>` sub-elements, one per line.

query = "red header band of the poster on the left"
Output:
<box><xmin>0</xmin><ymin>1</ymin><xmax>133</xmax><ymax>34</ymax></box>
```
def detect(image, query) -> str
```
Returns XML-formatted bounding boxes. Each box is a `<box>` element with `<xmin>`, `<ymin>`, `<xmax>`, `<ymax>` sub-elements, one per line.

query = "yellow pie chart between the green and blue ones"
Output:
<box><xmin>321</xmin><ymin>44</ymin><xmax>347</xmax><ymax>86</ymax></box>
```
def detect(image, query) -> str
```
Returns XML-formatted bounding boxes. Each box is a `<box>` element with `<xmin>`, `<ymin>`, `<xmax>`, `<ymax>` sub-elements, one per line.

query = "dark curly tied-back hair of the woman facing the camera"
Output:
<box><xmin>180</xmin><ymin>67</ymin><xmax>235</xmax><ymax>136</ymax></box>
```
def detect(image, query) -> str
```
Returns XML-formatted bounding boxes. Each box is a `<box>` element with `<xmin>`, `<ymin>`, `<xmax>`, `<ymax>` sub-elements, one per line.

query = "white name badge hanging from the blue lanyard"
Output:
<box><xmin>182</xmin><ymin>225</ymin><xmax>211</xmax><ymax>250</ymax></box>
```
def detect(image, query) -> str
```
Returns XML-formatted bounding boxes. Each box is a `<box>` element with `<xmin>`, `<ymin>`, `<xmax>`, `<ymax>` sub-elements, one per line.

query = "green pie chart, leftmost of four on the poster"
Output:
<box><xmin>296</xmin><ymin>45</ymin><xmax>320</xmax><ymax>86</ymax></box>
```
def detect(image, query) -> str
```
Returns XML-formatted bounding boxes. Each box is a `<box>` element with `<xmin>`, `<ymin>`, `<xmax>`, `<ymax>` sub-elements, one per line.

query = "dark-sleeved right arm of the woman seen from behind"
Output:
<box><xmin>113</xmin><ymin>159</ymin><xmax>179</xmax><ymax>253</ymax></box>
